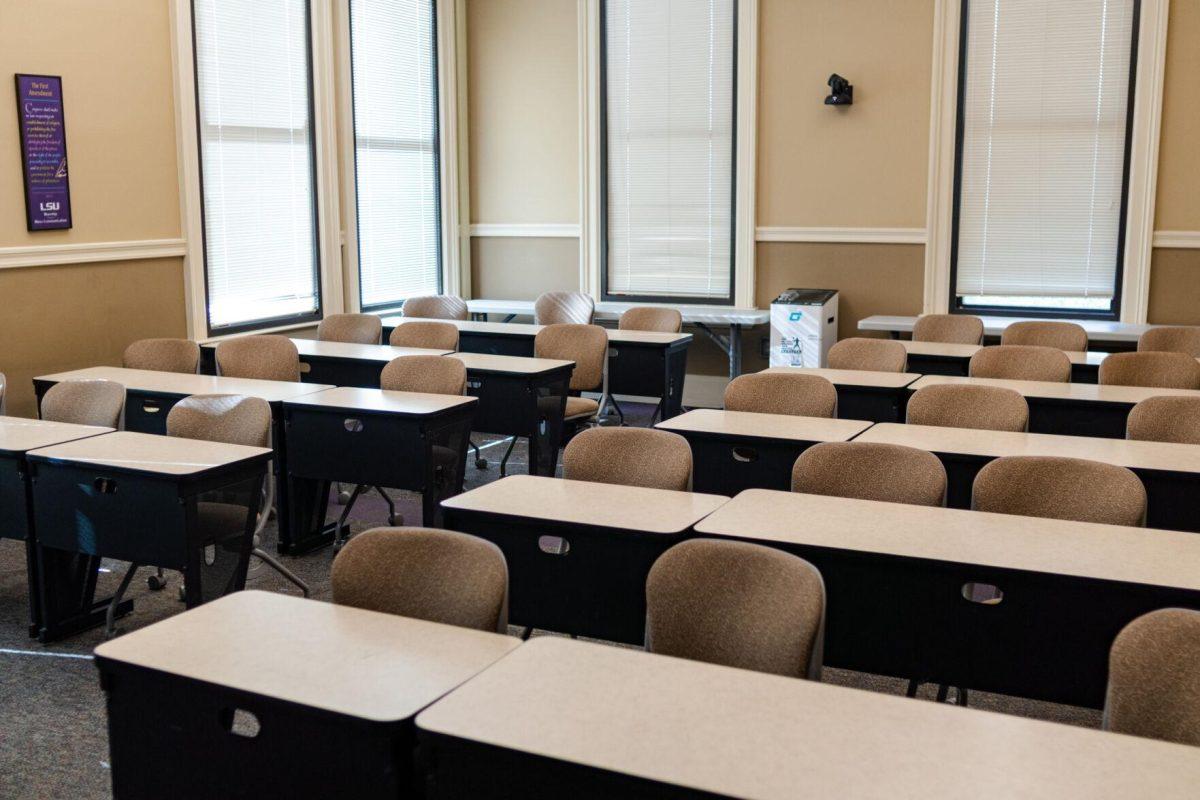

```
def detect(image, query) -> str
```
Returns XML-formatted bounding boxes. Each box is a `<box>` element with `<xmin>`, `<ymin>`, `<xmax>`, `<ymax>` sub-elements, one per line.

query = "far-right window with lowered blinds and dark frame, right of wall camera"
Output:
<box><xmin>950</xmin><ymin>0</ymin><xmax>1138</xmax><ymax>317</ymax></box>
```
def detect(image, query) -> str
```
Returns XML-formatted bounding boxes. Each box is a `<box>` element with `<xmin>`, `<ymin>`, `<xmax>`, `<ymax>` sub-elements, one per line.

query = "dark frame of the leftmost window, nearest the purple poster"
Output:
<box><xmin>187</xmin><ymin>0</ymin><xmax>325</xmax><ymax>337</ymax></box>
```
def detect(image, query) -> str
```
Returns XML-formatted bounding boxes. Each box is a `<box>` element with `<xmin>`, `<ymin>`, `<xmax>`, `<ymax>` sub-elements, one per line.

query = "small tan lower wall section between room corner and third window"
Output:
<box><xmin>470</xmin><ymin>236</ymin><xmax>580</xmax><ymax>300</ymax></box>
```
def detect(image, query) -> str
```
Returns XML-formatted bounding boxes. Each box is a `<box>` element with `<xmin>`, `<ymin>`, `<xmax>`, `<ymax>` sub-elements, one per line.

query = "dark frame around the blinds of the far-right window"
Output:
<box><xmin>948</xmin><ymin>0</ymin><xmax>1142</xmax><ymax>320</ymax></box>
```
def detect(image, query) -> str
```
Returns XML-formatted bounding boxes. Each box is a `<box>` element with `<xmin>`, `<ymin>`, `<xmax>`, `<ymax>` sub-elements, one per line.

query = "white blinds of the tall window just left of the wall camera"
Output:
<box><xmin>604</xmin><ymin>0</ymin><xmax>736</xmax><ymax>300</ymax></box>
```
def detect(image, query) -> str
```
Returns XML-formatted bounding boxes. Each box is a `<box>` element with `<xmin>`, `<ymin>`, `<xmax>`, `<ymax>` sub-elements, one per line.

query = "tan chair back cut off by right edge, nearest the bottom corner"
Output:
<box><xmin>1104</xmin><ymin>608</ymin><xmax>1200</xmax><ymax>746</ymax></box>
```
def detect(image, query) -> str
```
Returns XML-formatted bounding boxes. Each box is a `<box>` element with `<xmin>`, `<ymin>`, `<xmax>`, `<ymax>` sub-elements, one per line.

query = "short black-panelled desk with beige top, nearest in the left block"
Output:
<box><xmin>26</xmin><ymin>431</ymin><xmax>271</xmax><ymax>642</ymax></box>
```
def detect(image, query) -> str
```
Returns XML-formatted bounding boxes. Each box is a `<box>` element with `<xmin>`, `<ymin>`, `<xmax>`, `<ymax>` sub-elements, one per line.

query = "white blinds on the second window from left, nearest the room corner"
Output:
<box><xmin>350</xmin><ymin>0</ymin><xmax>442</xmax><ymax>309</ymax></box>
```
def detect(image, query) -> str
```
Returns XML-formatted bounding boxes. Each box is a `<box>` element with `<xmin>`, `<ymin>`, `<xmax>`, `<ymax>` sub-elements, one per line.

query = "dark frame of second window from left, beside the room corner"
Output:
<box><xmin>346</xmin><ymin>0</ymin><xmax>446</xmax><ymax>313</ymax></box>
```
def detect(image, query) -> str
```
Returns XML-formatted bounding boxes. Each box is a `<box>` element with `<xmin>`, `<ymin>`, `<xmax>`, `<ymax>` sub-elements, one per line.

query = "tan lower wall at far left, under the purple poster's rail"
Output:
<box><xmin>0</xmin><ymin>258</ymin><xmax>187</xmax><ymax>416</ymax></box>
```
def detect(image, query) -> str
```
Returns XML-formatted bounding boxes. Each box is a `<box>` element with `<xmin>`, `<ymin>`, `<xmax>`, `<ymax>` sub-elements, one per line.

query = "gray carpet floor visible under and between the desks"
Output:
<box><xmin>0</xmin><ymin>407</ymin><xmax>1100</xmax><ymax>800</ymax></box>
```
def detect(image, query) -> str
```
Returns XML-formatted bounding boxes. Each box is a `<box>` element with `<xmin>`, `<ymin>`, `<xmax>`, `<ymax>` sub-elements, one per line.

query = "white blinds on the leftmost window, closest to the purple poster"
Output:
<box><xmin>193</xmin><ymin>0</ymin><xmax>320</xmax><ymax>330</ymax></box>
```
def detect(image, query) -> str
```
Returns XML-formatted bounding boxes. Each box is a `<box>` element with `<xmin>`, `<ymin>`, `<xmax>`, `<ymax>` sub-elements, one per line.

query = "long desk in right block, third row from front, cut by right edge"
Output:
<box><xmin>856</xmin><ymin>425</ymin><xmax>1200</xmax><ymax>533</ymax></box>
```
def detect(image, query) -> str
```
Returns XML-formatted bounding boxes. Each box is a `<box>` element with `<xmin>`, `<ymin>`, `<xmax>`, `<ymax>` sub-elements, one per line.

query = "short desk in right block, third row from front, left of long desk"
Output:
<box><xmin>655</xmin><ymin>409</ymin><xmax>871</xmax><ymax>497</ymax></box>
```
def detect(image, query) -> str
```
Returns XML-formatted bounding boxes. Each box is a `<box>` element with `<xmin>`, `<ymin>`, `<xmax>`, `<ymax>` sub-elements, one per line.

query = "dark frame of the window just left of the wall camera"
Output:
<box><xmin>598</xmin><ymin>0</ymin><xmax>739</xmax><ymax>307</ymax></box>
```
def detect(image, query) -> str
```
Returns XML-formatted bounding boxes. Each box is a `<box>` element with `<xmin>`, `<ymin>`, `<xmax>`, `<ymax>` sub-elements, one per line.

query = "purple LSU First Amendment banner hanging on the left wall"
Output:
<box><xmin>17</xmin><ymin>74</ymin><xmax>71</xmax><ymax>230</ymax></box>
